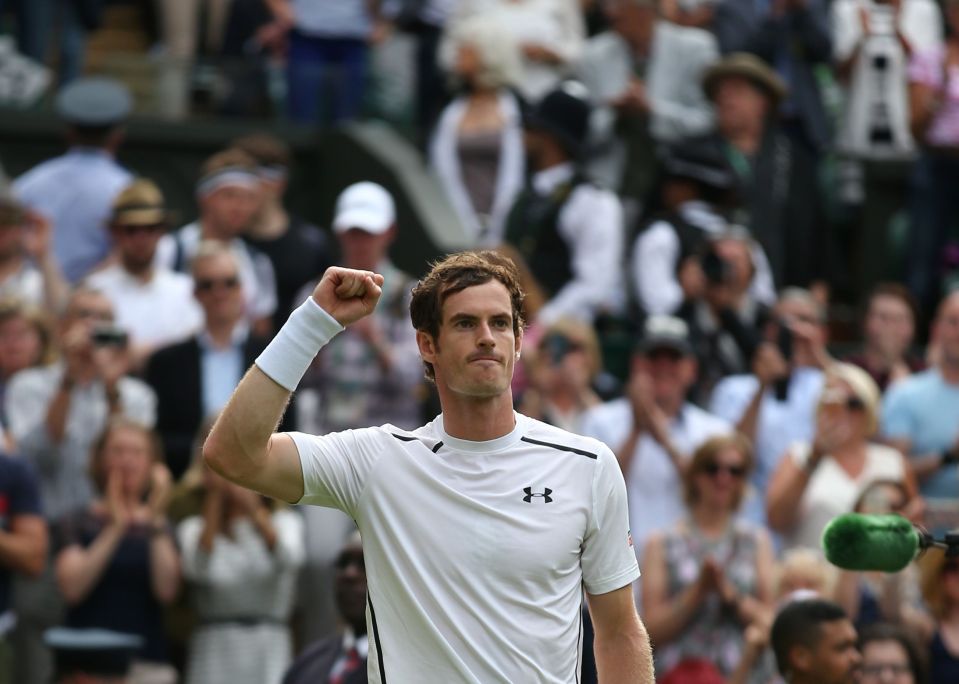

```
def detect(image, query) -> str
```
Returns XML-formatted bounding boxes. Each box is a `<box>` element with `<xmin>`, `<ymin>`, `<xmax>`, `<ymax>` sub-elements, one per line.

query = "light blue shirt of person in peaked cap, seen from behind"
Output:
<box><xmin>13</xmin><ymin>147</ymin><xmax>133</xmax><ymax>283</ymax></box>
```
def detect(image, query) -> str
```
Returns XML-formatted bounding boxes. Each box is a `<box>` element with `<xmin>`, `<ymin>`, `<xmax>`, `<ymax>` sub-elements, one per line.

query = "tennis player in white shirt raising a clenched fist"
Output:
<box><xmin>204</xmin><ymin>252</ymin><xmax>653</xmax><ymax>684</ymax></box>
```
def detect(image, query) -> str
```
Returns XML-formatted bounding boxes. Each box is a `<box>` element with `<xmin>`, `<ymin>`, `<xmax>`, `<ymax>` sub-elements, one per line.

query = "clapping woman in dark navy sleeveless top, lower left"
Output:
<box><xmin>56</xmin><ymin>418</ymin><xmax>180</xmax><ymax>684</ymax></box>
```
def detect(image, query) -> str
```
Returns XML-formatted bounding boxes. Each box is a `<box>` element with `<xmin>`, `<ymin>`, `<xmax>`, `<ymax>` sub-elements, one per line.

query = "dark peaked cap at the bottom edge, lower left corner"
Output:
<box><xmin>43</xmin><ymin>627</ymin><xmax>143</xmax><ymax>676</ymax></box>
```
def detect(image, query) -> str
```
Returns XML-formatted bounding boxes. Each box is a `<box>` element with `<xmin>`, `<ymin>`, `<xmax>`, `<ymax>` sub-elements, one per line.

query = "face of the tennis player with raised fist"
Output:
<box><xmin>416</xmin><ymin>280</ymin><xmax>522</xmax><ymax>398</ymax></box>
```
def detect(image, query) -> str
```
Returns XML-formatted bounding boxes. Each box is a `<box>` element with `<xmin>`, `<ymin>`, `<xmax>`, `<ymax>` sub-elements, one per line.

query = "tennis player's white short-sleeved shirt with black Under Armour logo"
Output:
<box><xmin>291</xmin><ymin>414</ymin><xmax>639</xmax><ymax>684</ymax></box>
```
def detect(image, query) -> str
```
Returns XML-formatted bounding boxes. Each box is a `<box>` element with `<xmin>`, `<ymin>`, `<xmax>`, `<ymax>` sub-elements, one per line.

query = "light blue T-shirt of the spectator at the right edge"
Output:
<box><xmin>881</xmin><ymin>368</ymin><xmax>959</xmax><ymax>498</ymax></box>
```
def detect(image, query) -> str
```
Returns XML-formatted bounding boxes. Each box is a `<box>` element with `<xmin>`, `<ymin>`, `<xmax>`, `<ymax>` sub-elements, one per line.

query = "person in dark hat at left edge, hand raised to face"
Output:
<box><xmin>0</xmin><ymin>195</ymin><xmax>68</xmax><ymax>311</ymax></box>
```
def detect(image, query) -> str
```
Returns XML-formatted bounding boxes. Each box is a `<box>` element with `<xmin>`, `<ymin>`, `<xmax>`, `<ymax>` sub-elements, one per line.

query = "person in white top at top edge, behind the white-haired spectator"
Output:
<box><xmin>440</xmin><ymin>0</ymin><xmax>586</xmax><ymax>102</ymax></box>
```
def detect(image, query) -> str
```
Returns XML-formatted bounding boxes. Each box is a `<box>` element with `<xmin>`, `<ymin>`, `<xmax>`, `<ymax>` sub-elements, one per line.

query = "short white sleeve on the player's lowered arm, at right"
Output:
<box><xmin>582</xmin><ymin>448</ymin><xmax>639</xmax><ymax>595</ymax></box>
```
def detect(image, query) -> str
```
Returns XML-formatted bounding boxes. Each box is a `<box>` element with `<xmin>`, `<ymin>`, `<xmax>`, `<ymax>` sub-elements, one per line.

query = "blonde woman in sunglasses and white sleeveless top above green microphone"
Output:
<box><xmin>766</xmin><ymin>363</ymin><xmax>917</xmax><ymax>549</ymax></box>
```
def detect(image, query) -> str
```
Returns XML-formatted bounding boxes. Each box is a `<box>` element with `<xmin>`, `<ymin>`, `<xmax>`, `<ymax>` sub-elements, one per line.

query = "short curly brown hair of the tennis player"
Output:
<box><xmin>410</xmin><ymin>250</ymin><xmax>526</xmax><ymax>380</ymax></box>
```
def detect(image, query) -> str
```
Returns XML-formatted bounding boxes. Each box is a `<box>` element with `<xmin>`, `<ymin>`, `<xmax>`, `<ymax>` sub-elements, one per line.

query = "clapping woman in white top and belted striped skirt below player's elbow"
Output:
<box><xmin>177</xmin><ymin>462</ymin><xmax>304</xmax><ymax>684</ymax></box>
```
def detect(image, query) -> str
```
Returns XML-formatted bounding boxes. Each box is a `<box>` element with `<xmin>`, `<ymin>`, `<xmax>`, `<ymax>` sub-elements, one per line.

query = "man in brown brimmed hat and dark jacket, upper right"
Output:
<box><xmin>692</xmin><ymin>53</ymin><xmax>828</xmax><ymax>287</ymax></box>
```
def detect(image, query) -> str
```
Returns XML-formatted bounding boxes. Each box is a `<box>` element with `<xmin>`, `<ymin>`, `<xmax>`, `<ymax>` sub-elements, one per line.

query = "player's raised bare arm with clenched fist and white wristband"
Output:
<box><xmin>203</xmin><ymin>267</ymin><xmax>383</xmax><ymax>503</ymax></box>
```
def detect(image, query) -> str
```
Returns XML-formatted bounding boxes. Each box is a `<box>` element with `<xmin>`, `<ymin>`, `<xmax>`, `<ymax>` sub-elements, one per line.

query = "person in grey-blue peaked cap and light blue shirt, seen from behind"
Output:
<box><xmin>13</xmin><ymin>78</ymin><xmax>133</xmax><ymax>283</ymax></box>
